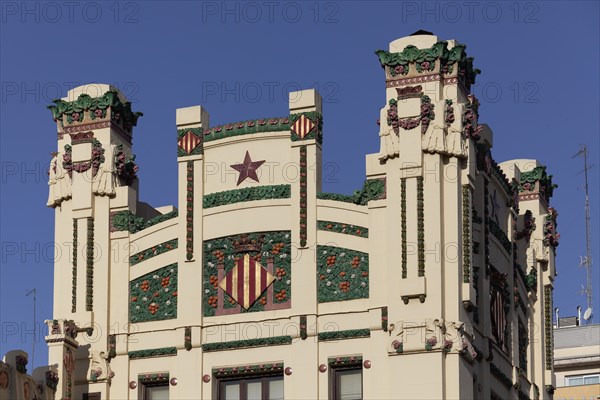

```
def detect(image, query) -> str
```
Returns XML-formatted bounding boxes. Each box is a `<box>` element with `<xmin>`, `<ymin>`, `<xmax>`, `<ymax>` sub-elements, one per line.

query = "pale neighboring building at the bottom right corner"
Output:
<box><xmin>554</xmin><ymin>317</ymin><xmax>600</xmax><ymax>400</ymax></box>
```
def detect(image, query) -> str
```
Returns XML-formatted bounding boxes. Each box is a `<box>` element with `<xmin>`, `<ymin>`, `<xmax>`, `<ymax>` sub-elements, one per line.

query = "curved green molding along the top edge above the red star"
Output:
<box><xmin>203</xmin><ymin>117</ymin><xmax>291</xmax><ymax>143</ymax></box>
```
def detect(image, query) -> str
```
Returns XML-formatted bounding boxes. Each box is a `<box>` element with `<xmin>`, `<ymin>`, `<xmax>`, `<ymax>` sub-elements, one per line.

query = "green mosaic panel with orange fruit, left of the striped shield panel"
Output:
<box><xmin>129</xmin><ymin>263</ymin><xmax>177</xmax><ymax>322</ymax></box>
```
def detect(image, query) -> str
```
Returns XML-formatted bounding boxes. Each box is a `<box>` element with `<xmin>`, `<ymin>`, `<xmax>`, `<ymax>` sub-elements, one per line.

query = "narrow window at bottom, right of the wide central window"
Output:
<box><xmin>329</xmin><ymin>357</ymin><xmax>362</xmax><ymax>400</ymax></box>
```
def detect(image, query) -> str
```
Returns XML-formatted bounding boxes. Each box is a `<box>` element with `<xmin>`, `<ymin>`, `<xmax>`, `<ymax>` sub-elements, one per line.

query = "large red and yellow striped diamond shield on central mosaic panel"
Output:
<box><xmin>219</xmin><ymin>254</ymin><xmax>275</xmax><ymax>309</ymax></box>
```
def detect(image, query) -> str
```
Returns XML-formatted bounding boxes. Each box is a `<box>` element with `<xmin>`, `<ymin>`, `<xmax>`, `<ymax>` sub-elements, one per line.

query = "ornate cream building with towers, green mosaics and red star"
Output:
<box><xmin>38</xmin><ymin>32</ymin><xmax>558</xmax><ymax>400</ymax></box>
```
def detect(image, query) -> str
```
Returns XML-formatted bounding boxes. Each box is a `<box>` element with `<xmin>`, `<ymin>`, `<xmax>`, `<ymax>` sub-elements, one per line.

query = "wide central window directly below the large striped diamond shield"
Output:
<box><xmin>213</xmin><ymin>363</ymin><xmax>283</xmax><ymax>400</ymax></box>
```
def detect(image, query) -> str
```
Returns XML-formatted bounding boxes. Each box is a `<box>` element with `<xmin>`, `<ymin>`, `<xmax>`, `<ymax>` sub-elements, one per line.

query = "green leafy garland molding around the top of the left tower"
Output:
<box><xmin>48</xmin><ymin>90</ymin><xmax>143</xmax><ymax>133</ymax></box>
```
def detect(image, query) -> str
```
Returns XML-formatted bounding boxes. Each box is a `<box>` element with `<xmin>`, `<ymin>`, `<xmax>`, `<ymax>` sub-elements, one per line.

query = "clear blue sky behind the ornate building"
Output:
<box><xmin>0</xmin><ymin>1</ymin><xmax>600</xmax><ymax>366</ymax></box>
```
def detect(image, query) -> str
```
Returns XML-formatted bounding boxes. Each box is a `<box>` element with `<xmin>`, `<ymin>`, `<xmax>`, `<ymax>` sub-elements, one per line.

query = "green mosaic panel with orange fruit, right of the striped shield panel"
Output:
<box><xmin>317</xmin><ymin>245</ymin><xmax>369</xmax><ymax>303</ymax></box>
